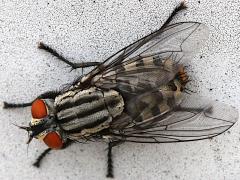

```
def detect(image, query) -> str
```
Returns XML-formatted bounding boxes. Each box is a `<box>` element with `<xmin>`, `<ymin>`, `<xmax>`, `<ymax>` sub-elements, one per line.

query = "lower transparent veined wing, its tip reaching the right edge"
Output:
<box><xmin>112</xmin><ymin>95</ymin><xmax>238</xmax><ymax>143</ymax></box>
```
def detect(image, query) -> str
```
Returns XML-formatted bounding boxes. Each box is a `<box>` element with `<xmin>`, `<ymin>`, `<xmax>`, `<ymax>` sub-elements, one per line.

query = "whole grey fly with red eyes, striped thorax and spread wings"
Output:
<box><xmin>4</xmin><ymin>2</ymin><xmax>238</xmax><ymax>177</ymax></box>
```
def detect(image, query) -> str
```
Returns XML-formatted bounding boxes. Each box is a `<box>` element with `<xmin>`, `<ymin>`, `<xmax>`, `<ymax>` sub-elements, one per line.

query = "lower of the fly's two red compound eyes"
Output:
<box><xmin>43</xmin><ymin>132</ymin><xmax>63</xmax><ymax>149</ymax></box>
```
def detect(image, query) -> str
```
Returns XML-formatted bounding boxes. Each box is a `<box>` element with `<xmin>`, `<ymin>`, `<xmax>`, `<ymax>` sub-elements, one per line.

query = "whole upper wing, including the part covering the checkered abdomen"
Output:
<box><xmin>88</xmin><ymin>22</ymin><xmax>208</xmax><ymax>93</ymax></box>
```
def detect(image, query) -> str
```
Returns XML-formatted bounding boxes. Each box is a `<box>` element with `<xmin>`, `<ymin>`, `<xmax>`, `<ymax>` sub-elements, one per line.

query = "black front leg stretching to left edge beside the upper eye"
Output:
<box><xmin>3</xmin><ymin>91</ymin><xmax>60</xmax><ymax>109</ymax></box>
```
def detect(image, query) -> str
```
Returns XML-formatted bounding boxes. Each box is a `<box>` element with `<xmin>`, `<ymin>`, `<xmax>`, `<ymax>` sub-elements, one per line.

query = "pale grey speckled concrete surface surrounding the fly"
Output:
<box><xmin>0</xmin><ymin>0</ymin><xmax>240</xmax><ymax>180</ymax></box>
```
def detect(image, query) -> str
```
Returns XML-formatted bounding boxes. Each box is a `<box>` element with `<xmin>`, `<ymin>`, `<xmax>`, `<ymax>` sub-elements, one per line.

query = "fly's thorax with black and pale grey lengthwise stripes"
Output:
<box><xmin>54</xmin><ymin>87</ymin><xmax>124</xmax><ymax>139</ymax></box>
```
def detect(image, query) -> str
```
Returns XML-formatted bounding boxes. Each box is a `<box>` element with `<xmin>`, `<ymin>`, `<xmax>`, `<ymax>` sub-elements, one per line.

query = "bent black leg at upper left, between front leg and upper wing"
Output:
<box><xmin>38</xmin><ymin>42</ymin><xmax>100</xmax><ymax>69</ymax></box>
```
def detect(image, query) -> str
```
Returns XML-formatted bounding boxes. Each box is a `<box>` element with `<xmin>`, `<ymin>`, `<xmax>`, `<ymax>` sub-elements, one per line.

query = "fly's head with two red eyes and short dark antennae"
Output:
<box><xmin>20</xmin><ymin>99</ymin><xmax>66</xmax><ymax>149</ymax></box>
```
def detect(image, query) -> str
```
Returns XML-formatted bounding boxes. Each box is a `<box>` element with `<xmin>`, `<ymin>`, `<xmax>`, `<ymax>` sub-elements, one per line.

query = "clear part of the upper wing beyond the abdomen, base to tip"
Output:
<box><xmin>91</xmin><ymin>22</ymin><xmax>208</xmax><ymax>74</ymax></box>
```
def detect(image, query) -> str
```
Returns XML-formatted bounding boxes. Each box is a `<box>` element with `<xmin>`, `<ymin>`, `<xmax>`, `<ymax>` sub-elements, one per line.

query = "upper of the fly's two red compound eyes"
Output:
<box><xmin>31</xmin><ymin>99</ymin><xmax>47</xmax><ymax>119</ymax></box>
